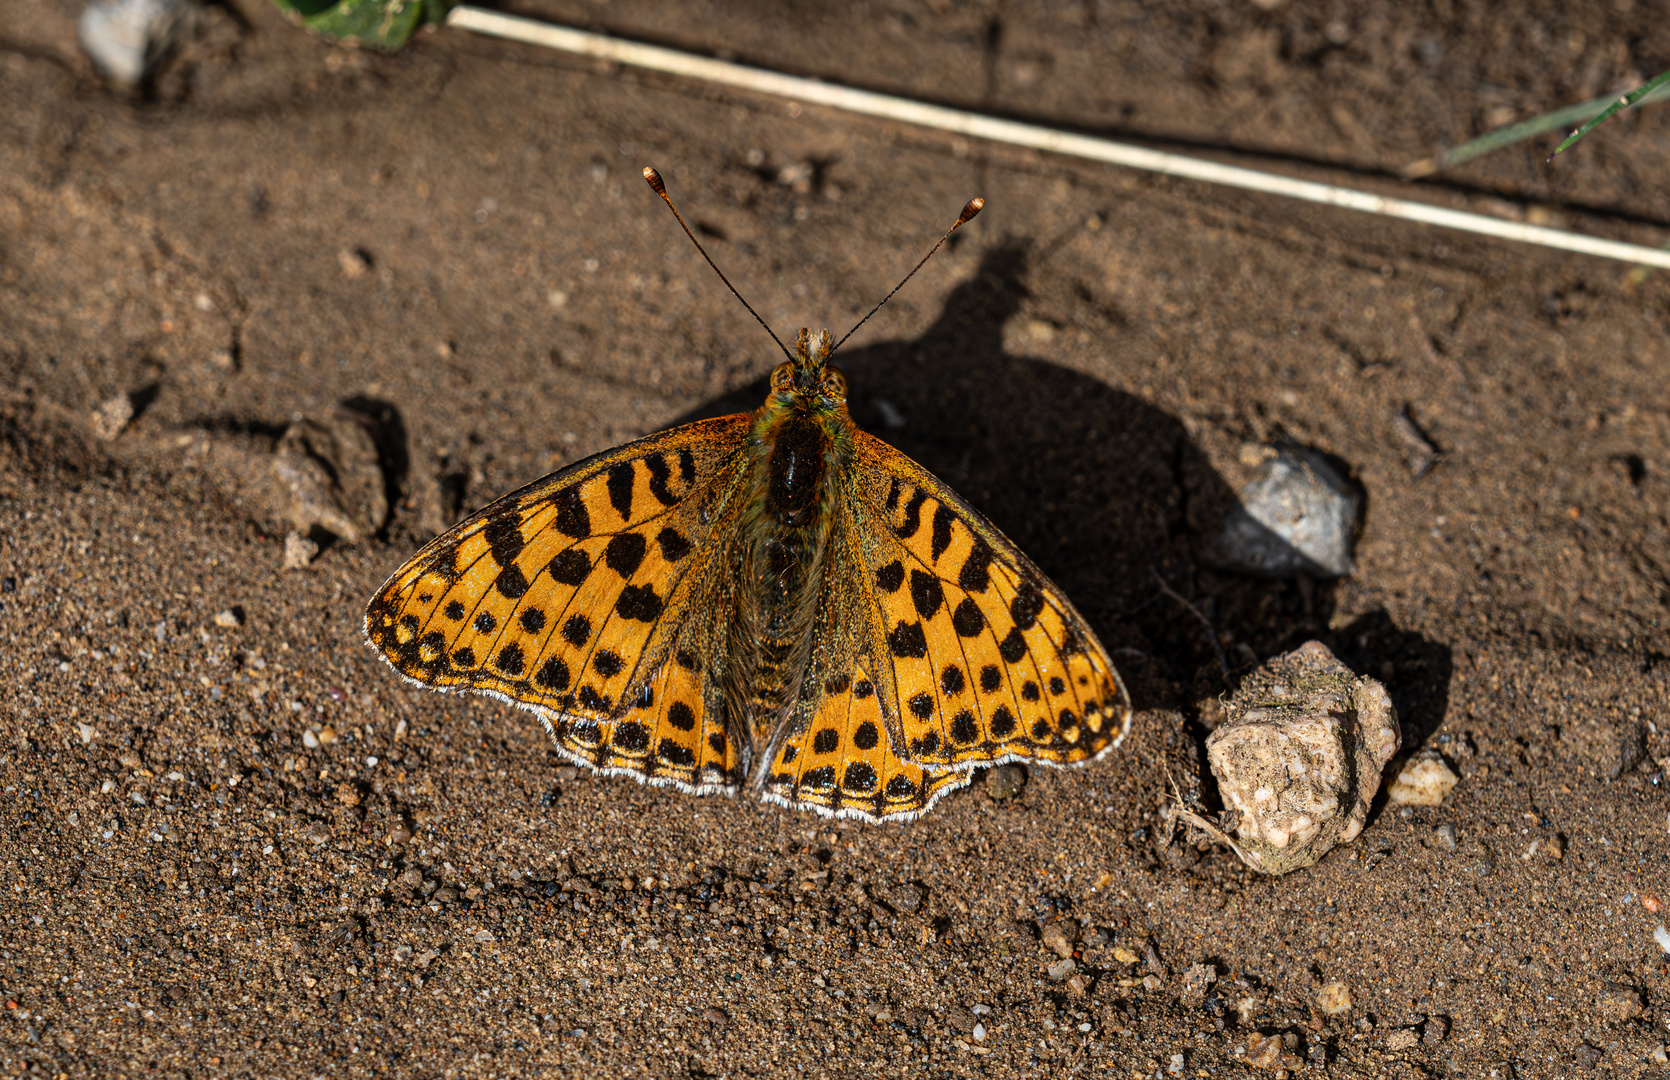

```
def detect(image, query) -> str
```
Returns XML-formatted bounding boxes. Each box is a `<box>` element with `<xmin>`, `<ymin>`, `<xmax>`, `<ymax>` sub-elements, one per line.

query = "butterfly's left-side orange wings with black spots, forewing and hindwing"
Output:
<box><xmin>366</xmin><ymin>416</ymin><xmax>748</xmax><ymax>791</ymax></box>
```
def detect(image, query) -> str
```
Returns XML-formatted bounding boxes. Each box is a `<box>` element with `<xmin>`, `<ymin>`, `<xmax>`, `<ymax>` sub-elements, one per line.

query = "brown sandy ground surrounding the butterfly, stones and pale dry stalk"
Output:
<box><xmin>0</xmin><ymin>0</ymin><xmax>1670</xmax><ymax>1078</ymax></box>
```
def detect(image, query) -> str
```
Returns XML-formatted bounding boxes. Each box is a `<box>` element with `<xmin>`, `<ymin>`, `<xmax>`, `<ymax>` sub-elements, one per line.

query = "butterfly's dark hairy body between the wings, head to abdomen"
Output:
<box><xmin>726</xmin><ymin>331</ymin><xmax>852</xmax><ymax>777</ymax></box>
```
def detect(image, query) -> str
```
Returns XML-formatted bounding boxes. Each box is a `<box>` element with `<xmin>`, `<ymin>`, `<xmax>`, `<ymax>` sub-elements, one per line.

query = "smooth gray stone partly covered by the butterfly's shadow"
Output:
<box><xmin>1209</xmin><ymin>446</ymin><xmax>1363</xmax><ymax>578</ymax></box>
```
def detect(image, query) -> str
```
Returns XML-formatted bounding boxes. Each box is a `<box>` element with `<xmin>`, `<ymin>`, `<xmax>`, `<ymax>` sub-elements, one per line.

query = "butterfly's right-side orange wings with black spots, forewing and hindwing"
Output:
<box><xmin>765</xmin><ymin>432</ymin><xmax>1131</xmax><ymax>820</ymax></box>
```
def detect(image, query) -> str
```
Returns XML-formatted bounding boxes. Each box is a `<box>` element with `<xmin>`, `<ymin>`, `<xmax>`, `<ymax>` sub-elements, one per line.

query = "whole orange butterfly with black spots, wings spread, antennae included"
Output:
<box><xmin>364</xmin><ymin>169</ymin><xmax>1131</xmax><ymax>821</ymax></box>
